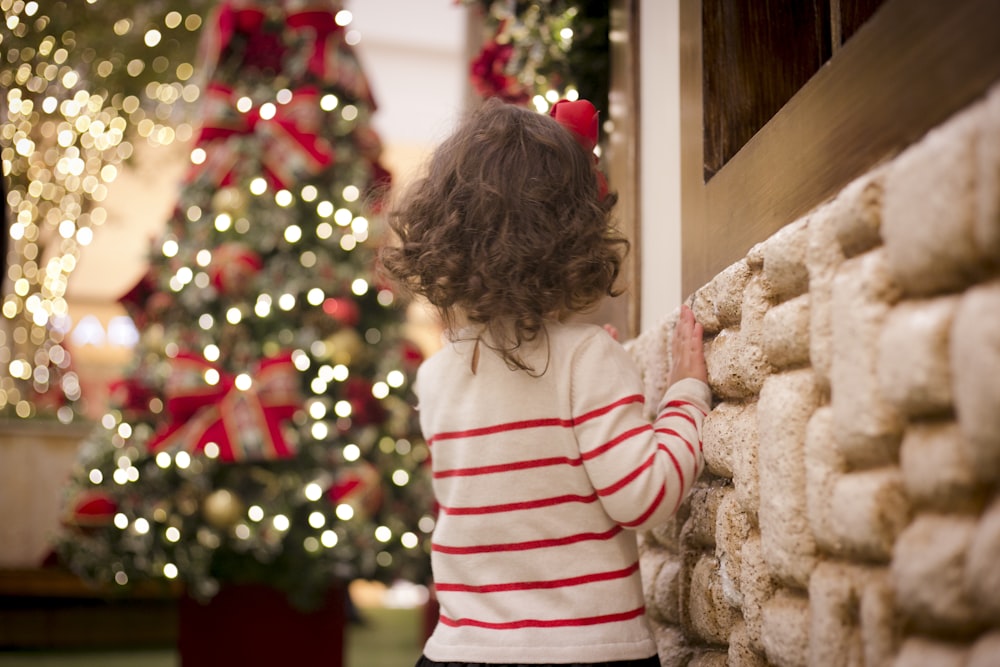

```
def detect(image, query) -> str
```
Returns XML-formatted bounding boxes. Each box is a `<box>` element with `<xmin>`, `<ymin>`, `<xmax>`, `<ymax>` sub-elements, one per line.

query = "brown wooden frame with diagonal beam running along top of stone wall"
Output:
<box><xmin>681</xmin><ymin>0</ymin><xmax>1000</xmax><ymax>294</ymax></box>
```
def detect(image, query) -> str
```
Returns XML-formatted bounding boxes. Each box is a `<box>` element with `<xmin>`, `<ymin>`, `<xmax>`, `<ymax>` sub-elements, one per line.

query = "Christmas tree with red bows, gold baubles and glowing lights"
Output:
<box><xmin>59</xmin><ymin>0</ymin><xmax>434</xmax><ymax>607</ymax></box>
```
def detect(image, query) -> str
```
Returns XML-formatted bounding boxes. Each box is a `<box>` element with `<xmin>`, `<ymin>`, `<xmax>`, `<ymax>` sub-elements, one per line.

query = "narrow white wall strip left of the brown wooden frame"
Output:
<box><xmin>639</xmin><ymin>0</ymin><xmax>685</xmax><ymax>330</ymax></box>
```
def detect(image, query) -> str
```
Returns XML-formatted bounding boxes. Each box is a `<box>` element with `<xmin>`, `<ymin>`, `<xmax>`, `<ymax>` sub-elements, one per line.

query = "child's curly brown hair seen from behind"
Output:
<box><xmin>381</xmin><ymin>100</ymin><xmax>628</xmax><ymax>372</ymax></box>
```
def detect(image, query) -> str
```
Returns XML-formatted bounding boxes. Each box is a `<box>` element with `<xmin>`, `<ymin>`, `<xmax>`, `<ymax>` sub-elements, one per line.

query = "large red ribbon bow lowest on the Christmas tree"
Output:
<box><xmin>148</xmin><ymin>353</ymin><xmax>300</xmax><ymax>462</ymax></box>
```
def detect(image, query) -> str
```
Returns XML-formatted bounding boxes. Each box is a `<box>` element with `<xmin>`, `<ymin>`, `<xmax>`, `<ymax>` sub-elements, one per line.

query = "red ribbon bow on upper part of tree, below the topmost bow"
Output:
<box><xmin>188</xmin><ymin>83</ymin><xmax>334</xmax><ymax>188</ymax></box>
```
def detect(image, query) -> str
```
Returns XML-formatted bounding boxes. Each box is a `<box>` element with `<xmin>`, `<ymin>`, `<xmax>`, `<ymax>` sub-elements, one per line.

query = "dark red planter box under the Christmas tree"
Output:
<box><xmin>177</xmin><ymin>585</ymin><xmax>347</xmax><ymax>667</ymax></box>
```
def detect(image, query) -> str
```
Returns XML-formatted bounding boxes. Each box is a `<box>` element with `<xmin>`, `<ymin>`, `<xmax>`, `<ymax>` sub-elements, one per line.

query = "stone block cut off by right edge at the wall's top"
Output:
<box><xmin>973</xmin><ymin>86</ymin><xmax>1000</xmax><ymax>267</ymax></box>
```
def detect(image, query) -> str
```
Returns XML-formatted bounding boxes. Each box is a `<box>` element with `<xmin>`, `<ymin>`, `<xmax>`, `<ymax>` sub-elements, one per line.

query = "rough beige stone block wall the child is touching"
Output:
<box><xmin>629</xmin><ymin>81</ymin><xmax>1000</xmax><ymax>667</ymax></box>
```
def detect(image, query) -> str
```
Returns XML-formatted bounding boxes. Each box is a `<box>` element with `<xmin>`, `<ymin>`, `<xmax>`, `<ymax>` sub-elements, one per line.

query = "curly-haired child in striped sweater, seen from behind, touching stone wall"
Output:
<box><xmin>382</xmin><ymin>96</ymin><xmax>710</xmax><ymax>667</ymax></box>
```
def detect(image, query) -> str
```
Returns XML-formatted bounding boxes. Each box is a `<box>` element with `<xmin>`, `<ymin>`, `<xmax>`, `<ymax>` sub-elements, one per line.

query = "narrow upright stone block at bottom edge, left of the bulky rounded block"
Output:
<box><xmin>858</xmin><ymin>568</ymin><xmax>901</xmax><ymax>667</ymax></box>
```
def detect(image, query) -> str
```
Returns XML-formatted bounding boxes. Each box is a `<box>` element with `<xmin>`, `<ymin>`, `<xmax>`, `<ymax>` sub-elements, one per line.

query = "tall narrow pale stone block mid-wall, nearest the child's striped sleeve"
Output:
<box><xmin>757</xmin><ymin>368</ymin><xmax>819</xmax><ymax>588</ymax></box>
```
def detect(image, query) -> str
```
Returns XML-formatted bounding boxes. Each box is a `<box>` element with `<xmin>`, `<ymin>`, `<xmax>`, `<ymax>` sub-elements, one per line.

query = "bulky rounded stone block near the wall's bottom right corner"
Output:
<box><xmin>890</xmin><ymin>514</ymin><xmax>979</xmax><ymax>634</ymax></box>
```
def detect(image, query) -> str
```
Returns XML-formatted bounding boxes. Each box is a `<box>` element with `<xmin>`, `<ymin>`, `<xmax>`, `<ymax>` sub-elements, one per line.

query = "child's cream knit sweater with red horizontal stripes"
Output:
<box><xmin>416</xmin><ymin>324</ymin><xmax>710</xmax><ymax>663</ymax></box>
